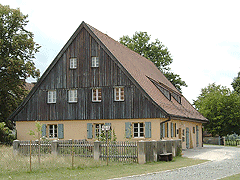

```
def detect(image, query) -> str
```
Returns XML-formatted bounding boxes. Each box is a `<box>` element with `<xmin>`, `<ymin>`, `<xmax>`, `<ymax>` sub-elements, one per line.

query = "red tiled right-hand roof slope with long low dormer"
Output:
<box><xmin>87</xmin><ymin>25</ymin><xmax>208</xmax><ymax>121</ymax></box>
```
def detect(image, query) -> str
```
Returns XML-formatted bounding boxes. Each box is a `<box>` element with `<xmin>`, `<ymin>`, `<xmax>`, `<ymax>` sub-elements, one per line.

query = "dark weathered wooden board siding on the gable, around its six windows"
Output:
<box><xmin>14</xmin><ymin>28</ymin><xmax>165</xmax><ymax>121</ymax></box>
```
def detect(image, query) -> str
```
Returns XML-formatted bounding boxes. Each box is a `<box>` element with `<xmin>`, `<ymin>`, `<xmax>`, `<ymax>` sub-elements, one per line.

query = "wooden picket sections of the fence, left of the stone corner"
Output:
<box><xmin>13</xmin><ymin>140</ymin><xmax>138</xmax><ymax>163</ymax></box>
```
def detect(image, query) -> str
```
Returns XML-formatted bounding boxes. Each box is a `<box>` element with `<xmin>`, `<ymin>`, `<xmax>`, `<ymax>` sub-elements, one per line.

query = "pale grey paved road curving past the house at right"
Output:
<box><xmin>113</xmin><ymin>145</ymin><xmax>240</xmax><ymax>180</ymax></box>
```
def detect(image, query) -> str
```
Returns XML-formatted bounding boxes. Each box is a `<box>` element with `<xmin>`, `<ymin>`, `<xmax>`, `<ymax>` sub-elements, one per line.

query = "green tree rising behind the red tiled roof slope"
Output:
<box><xmin>119</xmin><ymin>32</ymin><xmax>187</xmax><ymax>92</ymax></box>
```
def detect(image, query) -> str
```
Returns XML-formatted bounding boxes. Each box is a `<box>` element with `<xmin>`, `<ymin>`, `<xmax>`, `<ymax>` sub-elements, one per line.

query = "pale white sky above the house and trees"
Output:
<box><xmin>0</xmin><ymin>0</ymin><xmax>240</xmax><ymax>103</ymax></box>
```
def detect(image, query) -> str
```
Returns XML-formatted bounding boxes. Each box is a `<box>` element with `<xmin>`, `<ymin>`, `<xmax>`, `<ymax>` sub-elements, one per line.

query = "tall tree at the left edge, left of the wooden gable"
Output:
<box><xmin>0</xmin><ymin>4</ymin><xmax>40</xmax><ymax>129</ymax></box>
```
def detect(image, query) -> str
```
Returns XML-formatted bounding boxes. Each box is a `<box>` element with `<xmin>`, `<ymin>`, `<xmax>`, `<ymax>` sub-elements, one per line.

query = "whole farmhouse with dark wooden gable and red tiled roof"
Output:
<box><xmin>9</xmin><ymin>22</ymin><xmax>208</xmax><ymax>148</ymax></box>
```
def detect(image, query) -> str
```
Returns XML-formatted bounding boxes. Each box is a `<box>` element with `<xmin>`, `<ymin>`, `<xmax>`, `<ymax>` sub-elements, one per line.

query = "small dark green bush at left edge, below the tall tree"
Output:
<box><xmin>0</xmin><ymin>122</ymin><xmax>15</xmax><ymax>145</ymax></box>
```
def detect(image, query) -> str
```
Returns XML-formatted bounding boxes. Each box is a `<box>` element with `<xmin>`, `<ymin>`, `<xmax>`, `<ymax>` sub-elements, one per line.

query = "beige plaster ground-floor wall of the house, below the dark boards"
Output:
<box><xmin>16</xmin><ymin>118</ymin><xmax>202</xmax><ymax>149</ymax></box>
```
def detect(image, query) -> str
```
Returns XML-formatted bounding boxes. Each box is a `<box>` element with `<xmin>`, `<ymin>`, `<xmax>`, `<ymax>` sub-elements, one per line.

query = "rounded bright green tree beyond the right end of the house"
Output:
<box><xmin>194</xmin><ymin>83</ymin><xmax>240</xmax><ymax>136</ymax></box>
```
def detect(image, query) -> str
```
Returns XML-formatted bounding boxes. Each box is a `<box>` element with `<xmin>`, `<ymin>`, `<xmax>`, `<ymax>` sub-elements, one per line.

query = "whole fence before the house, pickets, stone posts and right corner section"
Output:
<box><xmin>13</xmin><ymin>140</ymin><xmax>182</xmax><ymax>163</ymax></box>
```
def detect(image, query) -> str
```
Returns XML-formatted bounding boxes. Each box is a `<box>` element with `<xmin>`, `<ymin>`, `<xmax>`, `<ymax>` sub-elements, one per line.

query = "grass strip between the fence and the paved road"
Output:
<box><xmin>0</xmin><ymin>146</ymin><xmax>205</xmax><ymax>179</ymax></box>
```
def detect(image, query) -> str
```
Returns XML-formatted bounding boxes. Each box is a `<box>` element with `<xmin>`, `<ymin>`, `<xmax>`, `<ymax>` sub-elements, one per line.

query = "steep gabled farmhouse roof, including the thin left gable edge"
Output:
<box><xmin>9</xmin><ymin>22</ymin><xmax>207</xmax><ymax>122</ymax></box>
